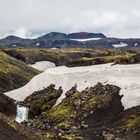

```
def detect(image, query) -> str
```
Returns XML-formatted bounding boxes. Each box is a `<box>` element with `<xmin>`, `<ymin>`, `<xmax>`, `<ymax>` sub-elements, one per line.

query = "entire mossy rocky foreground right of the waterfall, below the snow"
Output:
<box><xmin>10</xmin><ymin>83</ymin><xmax>140</xmax><ymax>140</ymax></box>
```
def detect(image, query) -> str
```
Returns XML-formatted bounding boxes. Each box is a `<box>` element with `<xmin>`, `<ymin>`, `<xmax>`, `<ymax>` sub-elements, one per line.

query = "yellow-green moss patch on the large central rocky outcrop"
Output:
<box><xmin>45</xmin><ymin>91</ymin><xmax>102</xmax><ymax>127</ymax></box>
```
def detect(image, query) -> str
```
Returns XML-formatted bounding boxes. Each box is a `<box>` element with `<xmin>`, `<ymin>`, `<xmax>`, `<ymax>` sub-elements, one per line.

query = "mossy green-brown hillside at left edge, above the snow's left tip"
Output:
<box><xmin>0</xmin><ymin>50</ymin><xmax>39</xmax><ymax>93</ymax></box>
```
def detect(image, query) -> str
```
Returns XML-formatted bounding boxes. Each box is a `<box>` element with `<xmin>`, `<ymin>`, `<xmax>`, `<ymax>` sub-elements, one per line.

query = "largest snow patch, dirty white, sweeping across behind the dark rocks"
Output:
<box><xmin>5</xmin><ymin>64</ymin><xmax>140</xmax><ymax>109</ymax></box>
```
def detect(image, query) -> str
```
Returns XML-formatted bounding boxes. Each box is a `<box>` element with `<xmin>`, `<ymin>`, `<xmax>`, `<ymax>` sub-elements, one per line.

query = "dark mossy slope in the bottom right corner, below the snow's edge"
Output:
<box><xmin>103</xmin><ymin>106</ymin><xmax>140</xmax><ymax>140</ymax></box>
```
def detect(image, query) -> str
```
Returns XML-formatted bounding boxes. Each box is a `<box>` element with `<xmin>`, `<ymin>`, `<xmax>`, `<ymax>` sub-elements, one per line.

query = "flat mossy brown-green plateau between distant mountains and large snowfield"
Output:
<box><xmin>4</xmin><ymin>48</ymin><xmax>136</xmax><ymax>67</ymax></box>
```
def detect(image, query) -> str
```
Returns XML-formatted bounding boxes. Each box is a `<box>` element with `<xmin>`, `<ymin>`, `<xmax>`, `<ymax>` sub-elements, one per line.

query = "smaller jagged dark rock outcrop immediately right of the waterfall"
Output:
<box><xmin>21</xmin><ymin>84</ymin><xmax>62</xmax><ymax>118</ymax></box>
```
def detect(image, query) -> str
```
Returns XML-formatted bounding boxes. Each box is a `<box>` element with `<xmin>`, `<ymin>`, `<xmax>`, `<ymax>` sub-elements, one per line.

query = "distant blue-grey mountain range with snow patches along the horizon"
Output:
<box><xmin>0</xmin><ymin>32</ymin><xmax>140</xmax><ymax>48</ymax></box>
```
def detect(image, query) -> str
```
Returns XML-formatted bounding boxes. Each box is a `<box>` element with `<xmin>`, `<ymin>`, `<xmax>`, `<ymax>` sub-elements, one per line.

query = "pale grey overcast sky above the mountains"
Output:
<box><xmin>0</xmin><ymin>0</ymin><xmax>140</xmax><ymax>38</ymax></box>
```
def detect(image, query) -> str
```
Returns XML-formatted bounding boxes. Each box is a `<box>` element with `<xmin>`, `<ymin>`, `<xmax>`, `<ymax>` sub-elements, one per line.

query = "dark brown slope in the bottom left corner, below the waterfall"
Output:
<box><xmin>0</xmin><ymin>114</ymin><xmax>44</xmax><ymax>140</ymax></box>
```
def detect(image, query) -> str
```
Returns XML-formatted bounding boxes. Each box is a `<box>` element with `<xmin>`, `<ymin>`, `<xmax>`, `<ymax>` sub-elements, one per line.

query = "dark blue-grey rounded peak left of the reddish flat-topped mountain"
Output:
<box><xmin>39</xmin><ymin>32</ymin><xmax>68</xmax><ymax>40</ymax></box>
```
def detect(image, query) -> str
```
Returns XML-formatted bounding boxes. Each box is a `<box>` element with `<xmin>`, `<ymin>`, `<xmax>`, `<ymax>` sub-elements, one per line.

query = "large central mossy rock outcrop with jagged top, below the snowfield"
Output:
<box><xmin>22</xmin><ymin>83</ymin><xmax>123</xmax><ymax>140</ymax></box>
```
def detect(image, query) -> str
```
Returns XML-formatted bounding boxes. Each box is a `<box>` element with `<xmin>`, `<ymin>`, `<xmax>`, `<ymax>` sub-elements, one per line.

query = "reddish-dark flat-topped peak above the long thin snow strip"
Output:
<box><xmin>69</xmin><ymin>32</ymin><xmax>106</xmax><ymax>39</ymax></box>
